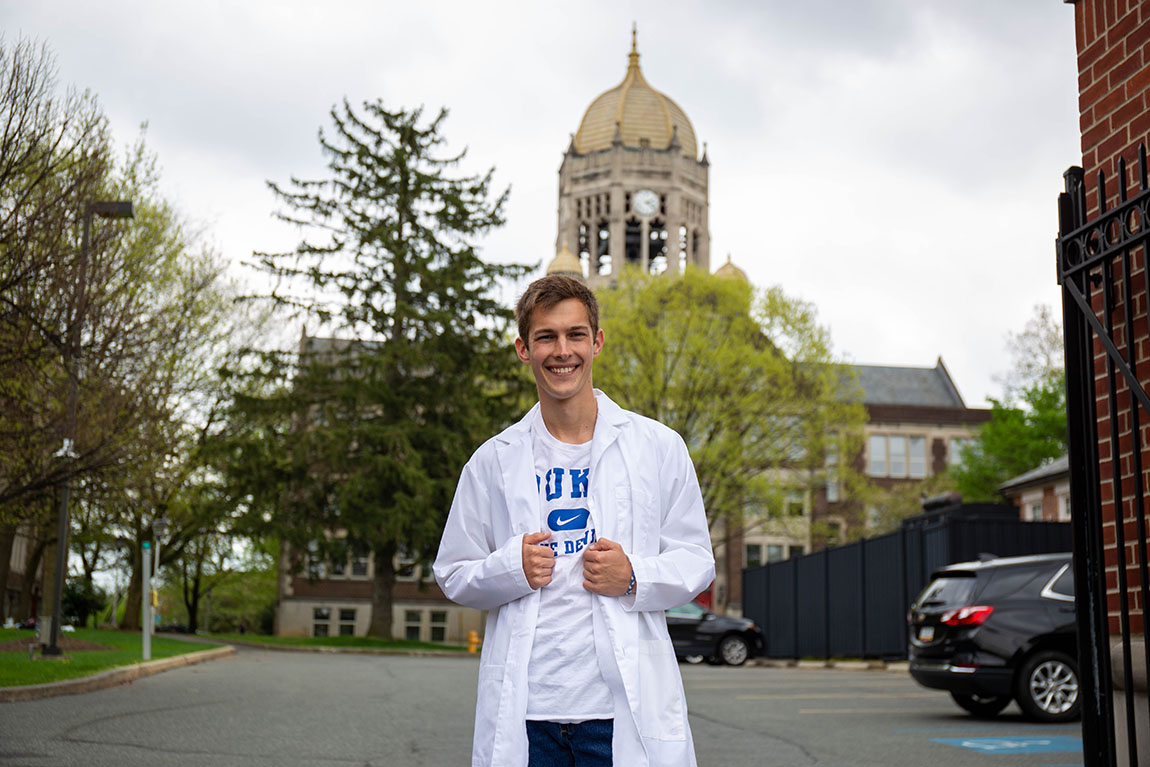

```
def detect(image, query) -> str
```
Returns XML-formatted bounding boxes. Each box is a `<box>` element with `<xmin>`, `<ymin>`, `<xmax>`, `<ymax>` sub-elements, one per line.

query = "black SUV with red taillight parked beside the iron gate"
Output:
<box><xmin>906</xmin><ymin>554</ymin><xmax>1079</xmax><ymax>722</ymax></box>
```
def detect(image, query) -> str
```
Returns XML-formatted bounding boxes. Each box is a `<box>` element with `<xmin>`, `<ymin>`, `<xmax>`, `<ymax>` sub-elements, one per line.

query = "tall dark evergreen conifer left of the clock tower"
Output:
<box><xmin>222</xmin><ymin>101</ymin><xmax>526</xmax><ymax>637</ymax></box>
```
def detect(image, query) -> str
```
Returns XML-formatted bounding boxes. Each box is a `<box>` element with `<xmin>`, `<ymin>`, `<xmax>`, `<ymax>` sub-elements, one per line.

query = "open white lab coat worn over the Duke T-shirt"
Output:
<box><xmin>434</xmin><ymin>390</ymin><xmax>715</xmax><ymax>767</ymax></box>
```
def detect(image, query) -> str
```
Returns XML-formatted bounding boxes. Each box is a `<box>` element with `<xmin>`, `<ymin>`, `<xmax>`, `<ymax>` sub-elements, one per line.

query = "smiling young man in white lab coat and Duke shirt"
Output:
<box><xmin>435</xmin><ymin>275</ymin><xmax>714</xmax><ymax>767</ymax></box>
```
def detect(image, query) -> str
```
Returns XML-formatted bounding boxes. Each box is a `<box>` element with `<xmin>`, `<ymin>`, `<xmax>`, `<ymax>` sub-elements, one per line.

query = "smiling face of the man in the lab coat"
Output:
<box><xmin>515</xmin><ymin>298</ymin><xmax>603</xmax><ymax>401</ymax></box>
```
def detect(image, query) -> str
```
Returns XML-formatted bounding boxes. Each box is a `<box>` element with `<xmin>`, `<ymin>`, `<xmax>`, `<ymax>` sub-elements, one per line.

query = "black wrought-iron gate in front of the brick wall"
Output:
<box><xmin>1058</xmin><ymin>145</ymin><xmax>1150</xmax><ymax>767</ymax></box>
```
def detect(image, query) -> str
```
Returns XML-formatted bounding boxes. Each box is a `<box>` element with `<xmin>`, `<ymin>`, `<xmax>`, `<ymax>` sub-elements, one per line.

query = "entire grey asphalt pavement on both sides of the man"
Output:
<box><xmin>0</xmin><ymin>649</ymin><xmax>1082</xmax><ymax>767</ymax></box>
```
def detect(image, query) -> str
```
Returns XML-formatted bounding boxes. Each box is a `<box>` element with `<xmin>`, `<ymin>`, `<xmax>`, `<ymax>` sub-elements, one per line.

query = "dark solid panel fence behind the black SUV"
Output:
<box><xmin>743</xmin><ymin>506</ymin><xmax>1071</xmax><ymax>658</ymax></box>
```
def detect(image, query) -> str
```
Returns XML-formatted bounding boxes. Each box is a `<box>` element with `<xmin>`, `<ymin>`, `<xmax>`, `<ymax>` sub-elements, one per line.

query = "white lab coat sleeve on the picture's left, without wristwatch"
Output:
<box><xmin>432</xmin><ymin>459</ymin><xmax>531</xmax><ymax>609</ymax></box>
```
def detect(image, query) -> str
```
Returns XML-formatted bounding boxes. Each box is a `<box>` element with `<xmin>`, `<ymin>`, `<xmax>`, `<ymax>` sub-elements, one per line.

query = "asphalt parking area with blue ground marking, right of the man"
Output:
<box><xmin>683</xmin><ymin>667</ymin><xmax>1082</xmax><ymax>767</ymax></box>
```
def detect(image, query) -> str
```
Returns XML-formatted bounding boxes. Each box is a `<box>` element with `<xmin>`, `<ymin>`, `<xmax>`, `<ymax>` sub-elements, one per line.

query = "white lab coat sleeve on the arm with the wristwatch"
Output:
<box><xmin>620</xmin><ymin>432</ymin><xmax>715</xmax><ymax>612</ymax></box>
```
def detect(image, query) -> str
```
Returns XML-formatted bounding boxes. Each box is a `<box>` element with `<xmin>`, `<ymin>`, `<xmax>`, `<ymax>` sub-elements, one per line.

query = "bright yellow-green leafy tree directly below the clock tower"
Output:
<box><xmin>596</xmin><ymin>269</ymin><xmax>866</xmax><ymax>538</ymax></box>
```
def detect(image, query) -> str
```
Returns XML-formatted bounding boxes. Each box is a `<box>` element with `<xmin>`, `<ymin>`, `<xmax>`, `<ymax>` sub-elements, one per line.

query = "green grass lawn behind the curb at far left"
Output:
<box><xmin>0</xmin><ymin>629</ymin><xmax>217</xmax><ymax>687</ymax></box>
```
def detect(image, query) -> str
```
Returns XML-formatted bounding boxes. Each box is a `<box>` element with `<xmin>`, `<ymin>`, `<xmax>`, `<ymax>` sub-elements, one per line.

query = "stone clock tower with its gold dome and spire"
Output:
<box><xmin>555</xmin><ymin>29</ymin><xmax>711</xmax><ymax>289</ymax></box>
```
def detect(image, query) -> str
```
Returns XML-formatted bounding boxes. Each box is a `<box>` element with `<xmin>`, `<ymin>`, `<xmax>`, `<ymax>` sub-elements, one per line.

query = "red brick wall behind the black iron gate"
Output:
<box><xmin>1074</xmin><ymin>0</ymin><xmax>1150</xmax><ymax>634</ymax></box>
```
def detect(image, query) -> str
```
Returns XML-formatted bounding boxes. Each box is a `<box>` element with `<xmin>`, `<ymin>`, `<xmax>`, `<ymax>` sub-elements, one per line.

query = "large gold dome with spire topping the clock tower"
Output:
<box><xmin>575</xmin><ymin>29</ymin><xmax>698</xmax><ymax>160</ymax></box>
